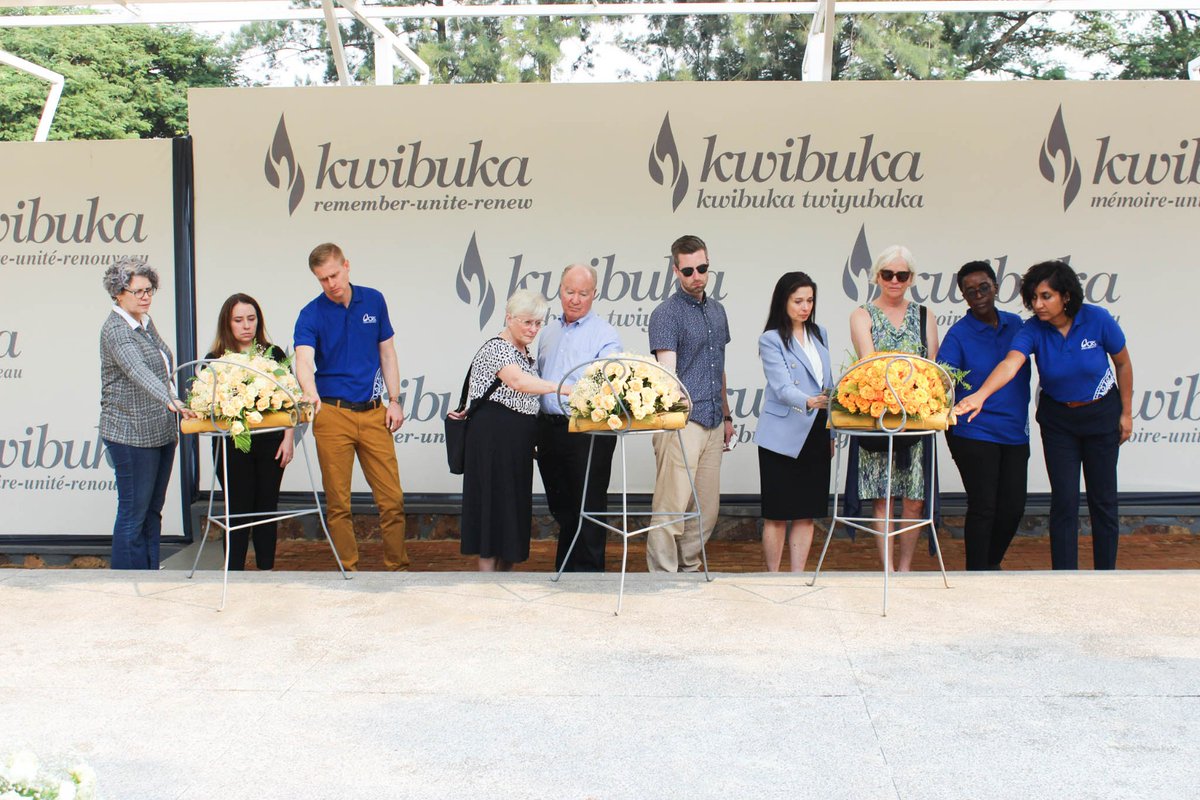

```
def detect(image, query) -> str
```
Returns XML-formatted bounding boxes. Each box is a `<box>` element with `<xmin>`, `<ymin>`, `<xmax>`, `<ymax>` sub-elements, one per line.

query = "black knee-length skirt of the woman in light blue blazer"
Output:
<box><xmin>758</xmin><ymin>411</ymin><xmax>830</xmax><ymax>519</ymax></box>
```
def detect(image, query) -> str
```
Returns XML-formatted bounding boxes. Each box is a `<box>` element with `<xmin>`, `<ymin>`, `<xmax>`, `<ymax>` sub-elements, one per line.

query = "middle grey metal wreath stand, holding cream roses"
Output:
<box><xmin>551</xmin><ymin>356</ymin><xmax>713</xmax><ymax>616</ymax></box>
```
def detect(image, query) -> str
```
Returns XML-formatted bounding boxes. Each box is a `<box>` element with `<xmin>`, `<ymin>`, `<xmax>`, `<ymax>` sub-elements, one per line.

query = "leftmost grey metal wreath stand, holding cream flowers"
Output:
<box><xmin>174</xmin><ymin>359</ymin><xmax>350</xmax><ymax>612</ymax></box>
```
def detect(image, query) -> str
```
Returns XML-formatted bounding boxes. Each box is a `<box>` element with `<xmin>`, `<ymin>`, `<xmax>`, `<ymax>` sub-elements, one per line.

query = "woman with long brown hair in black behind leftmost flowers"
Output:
<box><xmin>205</xmin><ymin>293</ymin><xmax>295</xmax><ymax>570</ymax></box>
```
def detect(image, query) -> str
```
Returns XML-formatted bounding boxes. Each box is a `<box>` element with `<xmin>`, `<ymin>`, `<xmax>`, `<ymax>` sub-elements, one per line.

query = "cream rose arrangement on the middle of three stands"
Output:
<box><xmin>568</xmin><ymin>353</ymin><xmax>688</xmax><ymax>431</ymax></box>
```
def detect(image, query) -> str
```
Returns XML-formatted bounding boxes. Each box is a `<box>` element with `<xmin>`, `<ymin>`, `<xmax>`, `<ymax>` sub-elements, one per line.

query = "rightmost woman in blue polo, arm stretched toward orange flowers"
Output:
<box><xmin>954</xmin><ymin>261</ymin><xmax>1133</xmax><ymax>570</ymax></box>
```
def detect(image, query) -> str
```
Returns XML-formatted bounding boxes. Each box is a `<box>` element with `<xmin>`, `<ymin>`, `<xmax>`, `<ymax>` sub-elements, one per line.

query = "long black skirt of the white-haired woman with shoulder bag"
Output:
<box><xmin>462</xmin><ymin>401</ymin><xmax>538</xmax><ymax>564</ymax></box>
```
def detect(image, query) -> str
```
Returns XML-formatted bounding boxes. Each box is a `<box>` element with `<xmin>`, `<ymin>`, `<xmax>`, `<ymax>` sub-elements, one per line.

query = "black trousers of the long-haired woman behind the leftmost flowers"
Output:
<box><xmin>212</xmin><ymin>433</ymin><xmax>283</xmax><ymax>570</ymax></box>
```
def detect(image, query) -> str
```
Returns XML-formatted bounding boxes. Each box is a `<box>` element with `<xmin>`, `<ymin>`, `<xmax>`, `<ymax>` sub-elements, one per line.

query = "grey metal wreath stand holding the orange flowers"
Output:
<box><xmin>809</xmin><ymin>353</ymin><xmax>954</xmax><ymax>616</ymax></box>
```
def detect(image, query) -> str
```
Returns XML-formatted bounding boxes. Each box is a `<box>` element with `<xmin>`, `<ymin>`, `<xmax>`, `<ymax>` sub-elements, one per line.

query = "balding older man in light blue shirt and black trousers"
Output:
<box><xmin>538</xmin><ymin>264</ymin><xmax>620</xmax><ymax>572</ymax></box>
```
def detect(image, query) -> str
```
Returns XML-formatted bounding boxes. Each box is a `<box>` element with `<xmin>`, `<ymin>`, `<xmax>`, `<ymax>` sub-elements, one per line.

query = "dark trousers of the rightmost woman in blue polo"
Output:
<box><xmin>1038</xmin><ymin>389</ymin><xmax>1121</xmax><ymax>570</ymax></box>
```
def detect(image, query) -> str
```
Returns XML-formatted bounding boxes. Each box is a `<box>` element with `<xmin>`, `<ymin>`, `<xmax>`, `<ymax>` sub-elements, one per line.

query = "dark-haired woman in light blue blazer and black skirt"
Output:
<box><xmin>754</xmin><ymin>272</ymin><xmax>833</xmax><ymax>572</ymax></box>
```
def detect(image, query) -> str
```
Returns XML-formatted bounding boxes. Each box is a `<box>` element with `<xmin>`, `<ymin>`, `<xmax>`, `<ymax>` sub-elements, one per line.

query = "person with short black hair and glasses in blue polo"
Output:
<box><xmin>937</xmin><ymin>261</ymin><xmax>1030</xmax><ymax>570</ymax></box>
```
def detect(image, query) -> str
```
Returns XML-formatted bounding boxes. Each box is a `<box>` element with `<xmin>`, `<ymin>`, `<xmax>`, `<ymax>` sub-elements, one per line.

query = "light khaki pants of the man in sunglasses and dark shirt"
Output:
<box><xmin>646</xmin><ymin>422</ymin><xmax>725</xmax><ymax>572</ymax></box>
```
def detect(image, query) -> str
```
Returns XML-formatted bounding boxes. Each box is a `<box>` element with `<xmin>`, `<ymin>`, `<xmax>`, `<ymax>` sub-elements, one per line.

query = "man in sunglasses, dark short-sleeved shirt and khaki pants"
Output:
<box><xmin>646</xmin><ymin>236</ymin><xmax>733</xmax><ymax>572</ymax></box>
